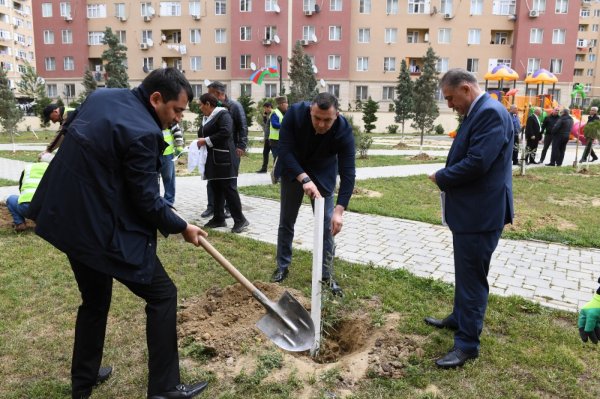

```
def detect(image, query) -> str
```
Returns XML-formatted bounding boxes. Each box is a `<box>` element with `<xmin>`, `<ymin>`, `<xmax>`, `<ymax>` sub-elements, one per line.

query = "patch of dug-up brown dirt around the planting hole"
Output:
<box><xmin>178</xmin><ymin>282</ymin><xmax>426</xmax><ymax>399</ymax></box>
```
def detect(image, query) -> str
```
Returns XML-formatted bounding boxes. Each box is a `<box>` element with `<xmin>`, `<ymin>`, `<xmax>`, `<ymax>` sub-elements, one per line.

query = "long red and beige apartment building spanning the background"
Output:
<box><xmin>32</xmin><ymin>0</ymin><xmax>600</xmax><ymax>110</ymax></box>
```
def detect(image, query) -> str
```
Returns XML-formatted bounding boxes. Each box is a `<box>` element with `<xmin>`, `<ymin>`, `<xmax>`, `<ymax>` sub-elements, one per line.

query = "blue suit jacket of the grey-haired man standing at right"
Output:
<box><xmin>435</xmin><ymin>93</ymin><xmax>514</xmax><ymax>233</ymax></box>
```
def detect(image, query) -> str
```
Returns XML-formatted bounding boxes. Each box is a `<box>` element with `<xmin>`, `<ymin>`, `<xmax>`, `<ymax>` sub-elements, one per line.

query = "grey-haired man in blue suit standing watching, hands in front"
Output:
<box><xmin>425</xmin><ymin>68</ymin><xmax>514</xmax><ymax>368</ymax></box>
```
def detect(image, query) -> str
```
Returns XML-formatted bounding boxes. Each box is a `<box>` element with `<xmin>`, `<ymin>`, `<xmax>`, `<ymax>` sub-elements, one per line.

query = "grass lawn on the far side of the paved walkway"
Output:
<box><xmin>238</xmin><ymin>165</ymin><xmax>600</xmax><ymax>248</ymax></box>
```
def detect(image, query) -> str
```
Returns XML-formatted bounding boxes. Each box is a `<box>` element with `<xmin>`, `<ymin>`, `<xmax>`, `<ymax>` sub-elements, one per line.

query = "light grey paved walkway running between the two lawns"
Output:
<box><xmin>0</xmin><ymin>146</ymin><xmax>600</xmax><ymax>311</ymax></box>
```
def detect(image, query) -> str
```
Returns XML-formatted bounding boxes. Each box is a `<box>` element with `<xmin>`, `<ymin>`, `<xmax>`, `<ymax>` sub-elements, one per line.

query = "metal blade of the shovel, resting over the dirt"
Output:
<box><xmin>256</xmin><ymin>291</ymin><xmax>315</xmax><ymax>352</ymax></box>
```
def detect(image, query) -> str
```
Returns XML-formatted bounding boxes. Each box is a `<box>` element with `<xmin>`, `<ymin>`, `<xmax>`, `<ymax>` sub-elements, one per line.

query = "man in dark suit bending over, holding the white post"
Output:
<box><xmin>271</xmin><ymin>93</ymin><xmax>356</xmax><ymax>295</ymax></box>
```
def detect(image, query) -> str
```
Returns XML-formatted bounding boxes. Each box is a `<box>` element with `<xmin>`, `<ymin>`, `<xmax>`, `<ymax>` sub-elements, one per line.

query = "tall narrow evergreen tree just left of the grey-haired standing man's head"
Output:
<box><xmin>411</xmin><ymin>47</ymin><xmax>440</xmax><ymax>150</ymax></box>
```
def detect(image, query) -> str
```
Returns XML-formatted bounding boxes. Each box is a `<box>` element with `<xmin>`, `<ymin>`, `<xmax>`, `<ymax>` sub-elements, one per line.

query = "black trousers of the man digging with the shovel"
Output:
<box><xmin>69</xmin><ymin>257</ymin><xmax>180</xmax><ymax>398</ymax></box>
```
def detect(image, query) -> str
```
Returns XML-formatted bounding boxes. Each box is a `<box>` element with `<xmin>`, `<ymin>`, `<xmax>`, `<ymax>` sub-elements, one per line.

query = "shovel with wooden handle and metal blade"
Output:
<box><xmin>200</xmin><ymin>237</ymin><xmax>315</xmax><ymax>352</ymax></box>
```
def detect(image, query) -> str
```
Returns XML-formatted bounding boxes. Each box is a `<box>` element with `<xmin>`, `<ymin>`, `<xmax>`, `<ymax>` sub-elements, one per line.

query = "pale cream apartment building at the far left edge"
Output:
<box><xmin>0</xmin><ymin>0</ymin><xmax>35</xmax><ymax>91</ymax></box>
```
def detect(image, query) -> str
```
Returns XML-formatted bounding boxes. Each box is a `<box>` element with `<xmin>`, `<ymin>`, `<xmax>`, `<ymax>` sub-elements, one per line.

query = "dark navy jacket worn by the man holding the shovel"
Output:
<box><xmin>30</xmin><ymin>87</ymin><xmax>187</xmax><ymax>284</ymax></box>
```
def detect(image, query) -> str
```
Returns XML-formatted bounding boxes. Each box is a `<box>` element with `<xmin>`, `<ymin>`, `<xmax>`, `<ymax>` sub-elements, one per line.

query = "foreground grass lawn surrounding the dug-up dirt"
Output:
<box><xmin>0</xmin><ymin>228</ymin><xmax>600</xmax><ymax>399</ymax></box>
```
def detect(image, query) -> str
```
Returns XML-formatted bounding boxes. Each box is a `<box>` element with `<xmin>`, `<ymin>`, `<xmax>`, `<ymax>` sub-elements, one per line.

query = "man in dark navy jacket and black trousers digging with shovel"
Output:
<box><xmin>29</xmin><ymin>68</ymin><xmax>207</xmax><ymax>399</ymax></box>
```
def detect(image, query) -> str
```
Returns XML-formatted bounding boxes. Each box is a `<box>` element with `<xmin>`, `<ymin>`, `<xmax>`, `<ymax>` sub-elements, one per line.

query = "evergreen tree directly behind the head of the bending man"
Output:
<box><xmin>288</xmin><ymin>41</ymin><xmax>317</xmax><ymax>104</ymax></box>
